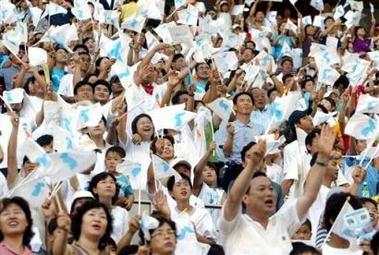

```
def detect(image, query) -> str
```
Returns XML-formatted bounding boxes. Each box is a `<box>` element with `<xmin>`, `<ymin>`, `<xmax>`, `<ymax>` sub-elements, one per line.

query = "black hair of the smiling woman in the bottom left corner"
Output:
<box><xmin>0</xmin><ymin>196</ymin><xmax>34</xmax><ymax>246</ymax></box>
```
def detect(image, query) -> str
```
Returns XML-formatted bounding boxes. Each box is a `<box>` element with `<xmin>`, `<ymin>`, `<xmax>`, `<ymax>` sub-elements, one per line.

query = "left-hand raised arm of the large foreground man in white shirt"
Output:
<box><xmin>224</xmin><ymin>140</ymin><xmax>266</xmax><ymax>221</ymax></box>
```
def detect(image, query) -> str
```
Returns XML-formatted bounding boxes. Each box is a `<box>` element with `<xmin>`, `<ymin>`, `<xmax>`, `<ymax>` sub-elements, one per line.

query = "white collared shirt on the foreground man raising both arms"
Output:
<box><xmin>219</xmin><ymin>200</ymin><xmax>304</xmax><ymax>255</ymax></box>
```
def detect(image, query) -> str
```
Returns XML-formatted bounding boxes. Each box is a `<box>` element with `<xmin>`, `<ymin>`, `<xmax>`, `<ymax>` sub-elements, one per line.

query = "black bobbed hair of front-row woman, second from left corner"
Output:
<box><xmin>71</xmin><ymin>200</ymin><xmax>113</xmax><ymax>250</ymax></box>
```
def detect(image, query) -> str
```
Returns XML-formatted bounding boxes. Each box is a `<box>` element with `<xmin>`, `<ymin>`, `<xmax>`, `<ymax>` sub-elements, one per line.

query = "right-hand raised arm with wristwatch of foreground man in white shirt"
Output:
<box><xmin>296</xmin><ymin>126</ymin><xmax>336</xmax><ymax>219</ymax></box>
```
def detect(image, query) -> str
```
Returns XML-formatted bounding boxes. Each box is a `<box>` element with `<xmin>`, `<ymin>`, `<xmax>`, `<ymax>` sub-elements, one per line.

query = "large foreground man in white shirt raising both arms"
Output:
<box><xmin>219</xmin><ymin>126</ymin><xmax>336</xmax><ymax>255</ymax></box>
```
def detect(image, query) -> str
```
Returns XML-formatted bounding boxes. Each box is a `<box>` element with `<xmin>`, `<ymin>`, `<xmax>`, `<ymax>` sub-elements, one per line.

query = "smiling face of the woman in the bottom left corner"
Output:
<box><xmin>0</xmin><ymin>203</ymin><xmax>28</xmax><ymax>237</ymax></box>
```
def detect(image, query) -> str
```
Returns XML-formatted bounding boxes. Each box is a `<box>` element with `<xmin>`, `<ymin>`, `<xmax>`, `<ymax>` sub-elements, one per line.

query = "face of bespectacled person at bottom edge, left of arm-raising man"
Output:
<box><xmin>150</xmin><ymin>222</ymin><xmax>176</xmax><ymax>254</ymax></box>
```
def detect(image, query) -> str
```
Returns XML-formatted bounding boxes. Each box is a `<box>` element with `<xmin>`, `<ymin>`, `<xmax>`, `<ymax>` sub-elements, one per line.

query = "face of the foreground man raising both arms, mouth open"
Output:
<box><xmin>243</xmin><ymin>176</ymin><xmax>276</xmax><ymax>217</ymax></box>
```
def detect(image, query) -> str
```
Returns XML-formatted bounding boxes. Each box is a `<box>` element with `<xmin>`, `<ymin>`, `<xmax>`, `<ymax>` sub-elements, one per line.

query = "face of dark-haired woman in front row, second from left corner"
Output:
<box><xmin>81</xmin><ymin>208</ymin><xmax>108</xmax><ymax>238</ymax></box>
